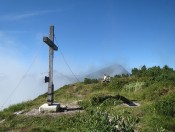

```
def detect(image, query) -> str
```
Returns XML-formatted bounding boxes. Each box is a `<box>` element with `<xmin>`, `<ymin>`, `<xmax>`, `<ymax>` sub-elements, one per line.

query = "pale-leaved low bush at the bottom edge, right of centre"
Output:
<box><xmin>85</xmin><ymin>108</ymin><xmax>138</xmax><ymax>132</ymax></box>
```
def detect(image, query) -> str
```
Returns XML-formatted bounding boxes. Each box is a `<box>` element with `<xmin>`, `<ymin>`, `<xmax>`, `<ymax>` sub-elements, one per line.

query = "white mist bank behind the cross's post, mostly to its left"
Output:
<box><xmin>0</xmin><ymin>32</ymin><xmax>80</xmax><ymax>110</ymax></box>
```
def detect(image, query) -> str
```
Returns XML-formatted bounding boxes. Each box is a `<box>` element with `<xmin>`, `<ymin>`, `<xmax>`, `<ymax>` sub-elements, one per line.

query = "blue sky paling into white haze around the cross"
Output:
<box><xmin>0</xmin><ymin>0</ymin><xmax>175</xmax><ymax>108</ymax></box>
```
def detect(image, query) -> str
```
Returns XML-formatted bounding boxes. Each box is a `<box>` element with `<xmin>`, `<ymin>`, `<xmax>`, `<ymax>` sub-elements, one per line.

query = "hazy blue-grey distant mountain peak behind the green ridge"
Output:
<box><xmin>85</xmin><ymin>64</ymin><xmax>130</xmax><ymax>78</ymax></box>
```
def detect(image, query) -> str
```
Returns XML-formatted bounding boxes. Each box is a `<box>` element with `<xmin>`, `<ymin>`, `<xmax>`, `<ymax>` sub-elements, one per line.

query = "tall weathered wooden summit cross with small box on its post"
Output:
<box><xmin>43</xmin><ymin>25</ymin><xmax>58</xmax><ymax>105</ymax></box>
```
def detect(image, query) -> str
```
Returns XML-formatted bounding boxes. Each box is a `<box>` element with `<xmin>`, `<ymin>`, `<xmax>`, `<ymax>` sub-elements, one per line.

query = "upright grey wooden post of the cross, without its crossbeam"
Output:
<box><xmin>47</xmin><ymin>26</ymin><xmax>54</xmax><ymax>105</ymax></box>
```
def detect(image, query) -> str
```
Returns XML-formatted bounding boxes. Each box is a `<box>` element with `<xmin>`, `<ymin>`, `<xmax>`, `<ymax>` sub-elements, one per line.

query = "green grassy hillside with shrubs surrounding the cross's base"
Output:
<box><xmin>0</xmin><ymin>66</ymin><xmax>175</xmax><ymax>132</ymax></box>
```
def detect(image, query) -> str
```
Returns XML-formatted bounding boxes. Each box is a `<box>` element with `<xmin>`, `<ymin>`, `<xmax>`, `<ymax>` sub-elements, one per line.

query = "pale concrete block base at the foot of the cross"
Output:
<box><xmin>39</xmin><ymin>103</ymin><xmax>60</xmax><ymax>113</ymax></box>
